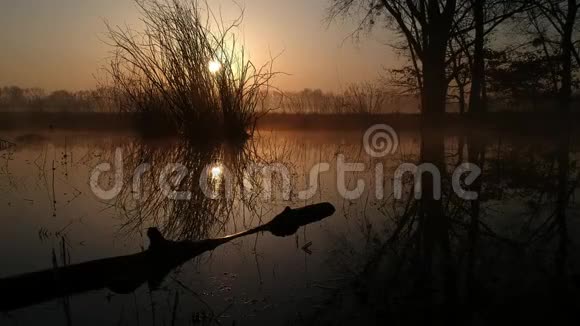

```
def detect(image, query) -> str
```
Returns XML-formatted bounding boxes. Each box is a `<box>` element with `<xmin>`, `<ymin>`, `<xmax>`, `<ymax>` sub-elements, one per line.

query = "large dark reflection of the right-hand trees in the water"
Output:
<box><xmin>317</xmin><ymin>128</ymin><xmax>580</xmax><ymax>325</ymax></box>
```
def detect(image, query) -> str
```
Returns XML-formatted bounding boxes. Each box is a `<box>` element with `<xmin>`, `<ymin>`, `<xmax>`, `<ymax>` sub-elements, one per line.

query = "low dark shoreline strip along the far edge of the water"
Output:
<box><xmin>0</xmin><ymin>112</ymin><xmax>580</xmax><ymax>135</ymax></box>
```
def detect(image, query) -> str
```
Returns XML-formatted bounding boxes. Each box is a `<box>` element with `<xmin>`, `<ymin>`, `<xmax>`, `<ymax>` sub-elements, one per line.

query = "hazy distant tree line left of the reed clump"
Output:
<box><xmin>0</xmin><ymin>86</ymin><xmax>117</xmax><ymax>113</ymax></box>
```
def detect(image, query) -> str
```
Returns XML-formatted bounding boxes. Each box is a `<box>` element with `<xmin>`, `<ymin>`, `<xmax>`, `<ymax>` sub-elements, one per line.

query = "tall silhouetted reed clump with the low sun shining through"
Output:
<box><xmin>107</xmin><ymin>0</ymin><xmax>275</xmax><ymax>138</ymax></box>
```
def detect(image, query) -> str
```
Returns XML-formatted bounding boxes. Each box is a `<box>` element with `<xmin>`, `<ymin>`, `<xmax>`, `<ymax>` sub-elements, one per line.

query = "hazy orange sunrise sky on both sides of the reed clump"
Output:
<box><xmin>0</xmin><ymin>0</ymin><xmax>399</xmax><ymax>91</ymax></box>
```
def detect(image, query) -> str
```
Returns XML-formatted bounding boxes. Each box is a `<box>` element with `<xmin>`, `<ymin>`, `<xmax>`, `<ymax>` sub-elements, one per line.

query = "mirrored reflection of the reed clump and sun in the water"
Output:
<box><xmin>111</xmin><ymin>141</ymin><xmax>245</xmax><ymax>239</ymax></box>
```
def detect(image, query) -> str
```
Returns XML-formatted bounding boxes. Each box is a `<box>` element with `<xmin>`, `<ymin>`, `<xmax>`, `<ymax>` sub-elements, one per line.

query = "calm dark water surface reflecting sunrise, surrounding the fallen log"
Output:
<box><xmin>0</xmin><ymin>130</ymin><xmax>580</xmax><ymax>325</ymax></box>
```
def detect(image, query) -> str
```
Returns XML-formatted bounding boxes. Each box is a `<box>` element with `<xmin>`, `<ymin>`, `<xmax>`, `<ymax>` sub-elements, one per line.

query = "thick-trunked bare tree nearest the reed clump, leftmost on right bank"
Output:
<box><xmin>330</xmin><ymin>0</ymin><xmax>466</xmax><ymax>115</ymax></box>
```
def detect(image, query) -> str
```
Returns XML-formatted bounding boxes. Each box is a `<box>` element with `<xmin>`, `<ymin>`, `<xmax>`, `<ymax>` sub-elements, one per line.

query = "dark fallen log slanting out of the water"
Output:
<box><xmin>0</xmin><ymin>203</ymin><xmax>334</xmax><ymax>311</ymax></box>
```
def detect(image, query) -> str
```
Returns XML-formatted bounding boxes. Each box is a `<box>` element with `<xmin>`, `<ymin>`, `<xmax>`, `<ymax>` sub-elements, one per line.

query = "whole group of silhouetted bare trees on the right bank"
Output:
<box><xmin>329</xmin><ymin>0</ymin><xmax>580</xmax><ymax>114</ymax></box>
